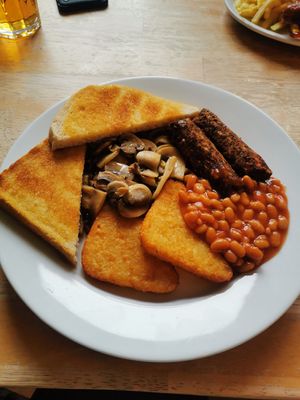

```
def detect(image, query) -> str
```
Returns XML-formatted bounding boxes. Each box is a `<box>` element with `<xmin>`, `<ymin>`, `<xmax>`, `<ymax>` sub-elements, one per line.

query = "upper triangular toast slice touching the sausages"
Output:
<box><xmin>49</xmin><ymin>85</ymin><xmax>200</xmax><ymax>149</ymax></box>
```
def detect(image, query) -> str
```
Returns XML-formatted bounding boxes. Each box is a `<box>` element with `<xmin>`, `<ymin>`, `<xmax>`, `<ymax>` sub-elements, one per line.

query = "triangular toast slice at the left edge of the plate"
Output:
<box><xmin>0</xmin><ymin>139</ymin><xmax>85</xmax><ymax>264</ymax></box>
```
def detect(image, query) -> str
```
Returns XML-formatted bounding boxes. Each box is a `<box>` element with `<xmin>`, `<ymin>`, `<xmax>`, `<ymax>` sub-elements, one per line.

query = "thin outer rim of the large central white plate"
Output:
<box><xmin>0</xmin><ymin>76</ymin><xmax>300</xmax><ymax>362</ymax></box>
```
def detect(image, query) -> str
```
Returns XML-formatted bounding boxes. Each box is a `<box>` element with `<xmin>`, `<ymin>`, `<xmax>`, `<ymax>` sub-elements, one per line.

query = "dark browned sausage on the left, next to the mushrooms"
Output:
<box><xmin>170</xmin><ymin>118</ymin><xmax>242</xmax><ymax>193</ymax></box>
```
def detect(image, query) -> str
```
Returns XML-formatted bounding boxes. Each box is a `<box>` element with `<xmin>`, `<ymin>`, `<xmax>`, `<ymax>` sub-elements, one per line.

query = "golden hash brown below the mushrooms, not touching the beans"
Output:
<box><xmin>82</xmin><ymin>205</ymin><xmax>178</xmax><ymax>293</ymax></box>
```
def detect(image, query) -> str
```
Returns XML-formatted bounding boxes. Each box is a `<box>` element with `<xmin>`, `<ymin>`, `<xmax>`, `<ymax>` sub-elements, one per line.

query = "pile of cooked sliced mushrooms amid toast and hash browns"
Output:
<box><xmin>82</xmin><ymin>130</ymin><xmax>186</xmax><ymax>222</ymax></box>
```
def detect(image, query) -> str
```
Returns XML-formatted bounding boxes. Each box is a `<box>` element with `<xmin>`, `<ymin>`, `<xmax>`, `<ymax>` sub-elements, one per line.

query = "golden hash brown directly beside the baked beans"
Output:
<box><xmin>141</xmin><ymin>180</ymin><xmax>232</xmax><ymax>282</ymax></box>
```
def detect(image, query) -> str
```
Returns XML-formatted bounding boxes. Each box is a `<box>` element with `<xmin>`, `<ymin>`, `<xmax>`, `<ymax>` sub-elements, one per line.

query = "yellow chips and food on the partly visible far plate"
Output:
<box><xmin>234</xmin><ymin>0</ymin><xmax>300</xmax><ymax>39</ymax></box>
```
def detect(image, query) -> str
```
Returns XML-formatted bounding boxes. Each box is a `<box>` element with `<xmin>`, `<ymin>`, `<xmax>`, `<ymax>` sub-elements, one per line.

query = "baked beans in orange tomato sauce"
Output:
<box><xmin>179</xmin><ymin>175</ymin><xmax>289</xmax><ymax>272</ymax></box>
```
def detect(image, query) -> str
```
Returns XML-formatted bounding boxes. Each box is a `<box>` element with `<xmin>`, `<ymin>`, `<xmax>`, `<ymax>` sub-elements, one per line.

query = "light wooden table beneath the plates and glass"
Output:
<box><xmin>0</xmin><ymin>0</ymin><xmax>300</xmax><ymax>399</ymax></box>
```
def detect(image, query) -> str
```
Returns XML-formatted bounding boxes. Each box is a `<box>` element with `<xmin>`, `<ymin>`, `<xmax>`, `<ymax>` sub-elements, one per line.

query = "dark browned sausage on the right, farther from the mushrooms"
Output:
<box><xmin>193</xmin><ymin>108</ymin><xmax>272</xmax><ymax>181</ymax></box>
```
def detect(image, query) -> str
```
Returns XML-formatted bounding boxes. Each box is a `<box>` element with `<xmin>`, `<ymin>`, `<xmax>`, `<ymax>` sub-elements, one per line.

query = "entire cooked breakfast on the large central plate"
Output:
<box><xmin>0</xmin><ymin>84</ymin><xmax>289</xmax><ymax>293</ymax></box>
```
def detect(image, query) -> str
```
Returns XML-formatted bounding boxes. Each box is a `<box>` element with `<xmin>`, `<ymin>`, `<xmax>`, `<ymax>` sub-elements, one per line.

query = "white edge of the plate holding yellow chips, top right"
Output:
<box><xmin>224</xmin><ymin>0</ymin><xmax>300</xmax><ymax>46</ymax></box>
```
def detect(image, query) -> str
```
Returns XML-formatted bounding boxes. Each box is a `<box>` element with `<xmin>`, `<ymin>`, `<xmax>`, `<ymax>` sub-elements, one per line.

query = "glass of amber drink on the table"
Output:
<box><xmin>0</xmin><ymin>0</ymin><xmax>41</xmax><ymax>39</ymax></box>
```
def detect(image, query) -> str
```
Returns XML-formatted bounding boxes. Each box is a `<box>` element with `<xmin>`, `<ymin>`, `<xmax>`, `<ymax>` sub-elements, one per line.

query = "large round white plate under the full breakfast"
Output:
<box><xmin>0</xmin><ymin>77</ymin><xmax>300</xmax><ymax>361</ymax></box>
